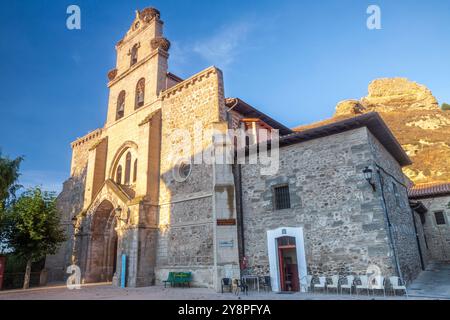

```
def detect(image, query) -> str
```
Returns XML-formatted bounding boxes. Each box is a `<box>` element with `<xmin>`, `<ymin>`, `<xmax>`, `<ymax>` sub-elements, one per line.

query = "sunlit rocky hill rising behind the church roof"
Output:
<box><xmin>299</xmin><ymin>78</ymin><xmax>450</xmax><ymax>183</ymax></box>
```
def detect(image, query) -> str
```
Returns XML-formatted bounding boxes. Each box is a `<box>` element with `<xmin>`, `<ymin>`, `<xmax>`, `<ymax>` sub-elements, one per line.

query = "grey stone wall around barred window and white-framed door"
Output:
<box><xmin>242</xmin><ymin>128</ymin><xmax>407</xmax><ymax>275</ymax></box>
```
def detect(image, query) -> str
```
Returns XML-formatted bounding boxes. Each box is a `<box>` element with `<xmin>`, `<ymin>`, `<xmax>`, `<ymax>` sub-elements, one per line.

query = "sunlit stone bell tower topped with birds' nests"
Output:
<box><xmin>106</xmin><ymin>8</ymin><xmax>170</xmax><ymax>126</ymax></box>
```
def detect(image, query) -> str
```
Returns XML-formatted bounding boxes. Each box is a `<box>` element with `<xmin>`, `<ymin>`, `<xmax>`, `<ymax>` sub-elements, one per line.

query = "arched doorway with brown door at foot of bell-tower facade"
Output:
<box><xmin>86</xmin><ymin>200</ymin><xmax>118</xmax><ymax>283</ymax></box>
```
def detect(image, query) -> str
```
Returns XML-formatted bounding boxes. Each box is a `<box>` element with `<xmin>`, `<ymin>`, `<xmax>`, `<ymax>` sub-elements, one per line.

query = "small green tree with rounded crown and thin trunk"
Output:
<box><xmin>7</xmin><ymin>187</ymin><xmax>66</xmax><ymax>289</ymax></box>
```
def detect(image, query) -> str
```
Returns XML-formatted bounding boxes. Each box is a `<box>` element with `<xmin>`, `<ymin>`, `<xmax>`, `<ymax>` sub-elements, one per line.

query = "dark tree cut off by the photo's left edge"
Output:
<box><xmin>0</xmin><ymin>151</ymin><xmax>23</xmax><ymax>253</ymax></box>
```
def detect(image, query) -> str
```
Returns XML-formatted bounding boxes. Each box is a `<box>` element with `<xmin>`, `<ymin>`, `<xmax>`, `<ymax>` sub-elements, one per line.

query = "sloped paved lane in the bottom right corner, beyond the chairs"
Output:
<box><xmin>409</xmin><ymin>263</ymin><xmax>450</xmax><ymax>299</ymax></box>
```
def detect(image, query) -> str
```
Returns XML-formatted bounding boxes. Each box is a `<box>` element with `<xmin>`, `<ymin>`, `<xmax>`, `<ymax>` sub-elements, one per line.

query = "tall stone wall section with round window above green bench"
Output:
<box><xmin>156</xmin><ymin>68</ymin><xmax>224</xmax><ymax>287</ymax></box>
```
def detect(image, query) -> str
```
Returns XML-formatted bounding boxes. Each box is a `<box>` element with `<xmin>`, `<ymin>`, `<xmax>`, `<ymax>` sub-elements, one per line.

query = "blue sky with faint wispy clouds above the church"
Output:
<box><xmin>0</xmin><ymin>0</ymin><xmax>450</xmax><ymax>191</ymax></box>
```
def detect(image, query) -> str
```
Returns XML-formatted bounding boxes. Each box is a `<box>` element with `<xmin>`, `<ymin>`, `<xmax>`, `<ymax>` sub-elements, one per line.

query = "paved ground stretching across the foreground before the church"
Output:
<box><xmin>0</xmin><ymin>264</ymin><xmax>450</xmax><ymax>300</ymax></box>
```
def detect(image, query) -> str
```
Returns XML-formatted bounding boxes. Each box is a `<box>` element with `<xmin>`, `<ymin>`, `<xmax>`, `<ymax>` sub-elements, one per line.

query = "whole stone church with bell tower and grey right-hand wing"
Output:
<box><xmin>46</xmin><ymin>8</ymin><xmax>432</xmax><ymax>291</ymax></box>
